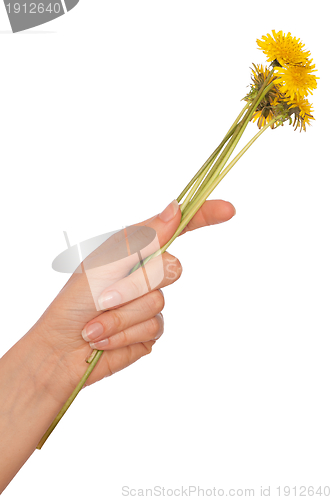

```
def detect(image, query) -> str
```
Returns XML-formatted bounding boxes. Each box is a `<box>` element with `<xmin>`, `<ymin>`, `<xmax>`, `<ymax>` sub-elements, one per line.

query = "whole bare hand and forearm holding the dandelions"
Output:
<box><xmin>0</xmin><ymin>197</ymin><xmax>235</xmax><ymax>493</ymax></box>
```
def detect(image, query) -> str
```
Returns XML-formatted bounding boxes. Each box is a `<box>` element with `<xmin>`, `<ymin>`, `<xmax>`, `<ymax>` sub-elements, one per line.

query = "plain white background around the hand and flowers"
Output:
<box><xmin>0</xmin><ymin>0</ymin><xmax>332</xmax><ymax>500</ymax></box>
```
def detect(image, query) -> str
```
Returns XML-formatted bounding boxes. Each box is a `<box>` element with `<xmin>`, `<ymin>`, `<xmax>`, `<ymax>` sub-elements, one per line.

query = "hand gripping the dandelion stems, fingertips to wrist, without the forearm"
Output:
<box><xmin>32</xmin><ymin>200</ymin><xmax>235</xmax><ymax>401</ymax></box>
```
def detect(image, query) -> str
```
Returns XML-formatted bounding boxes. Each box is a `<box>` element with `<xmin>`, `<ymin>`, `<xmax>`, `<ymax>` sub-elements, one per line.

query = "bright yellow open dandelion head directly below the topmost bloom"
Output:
<box><xmin>275</xmin><ymin>61</ymin><xmax>318</xmax><ymax>99</ymax></box>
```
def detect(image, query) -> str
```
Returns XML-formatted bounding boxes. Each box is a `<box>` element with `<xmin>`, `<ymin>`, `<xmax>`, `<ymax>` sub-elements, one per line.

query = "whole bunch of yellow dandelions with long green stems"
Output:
<box><xmin>37</xmin><ymin>30</ymin><xmax>317</xmax><ymax>449</ymax></box>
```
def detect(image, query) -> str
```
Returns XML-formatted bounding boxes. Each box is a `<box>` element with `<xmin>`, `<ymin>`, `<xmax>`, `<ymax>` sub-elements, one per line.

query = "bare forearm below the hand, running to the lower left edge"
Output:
<box><xmin>0</xmin><ymin>330</ymin><xmax>81</xmax><ymax>492</ymax></box>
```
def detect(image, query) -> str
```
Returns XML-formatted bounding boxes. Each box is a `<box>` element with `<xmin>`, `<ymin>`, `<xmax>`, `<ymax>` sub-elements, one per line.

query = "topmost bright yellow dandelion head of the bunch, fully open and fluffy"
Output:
<box><xmin>257</xmin><ymin>30</ymin><xmax>310</xmax><ymax>66</ymax></box>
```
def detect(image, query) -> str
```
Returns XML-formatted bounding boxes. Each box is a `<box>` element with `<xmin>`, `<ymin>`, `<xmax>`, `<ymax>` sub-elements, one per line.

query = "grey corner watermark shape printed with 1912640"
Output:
<box><xmin>4</xmin><ymin>0</ymin><xmax>79</xmax><ymax>33</ymax></box>
